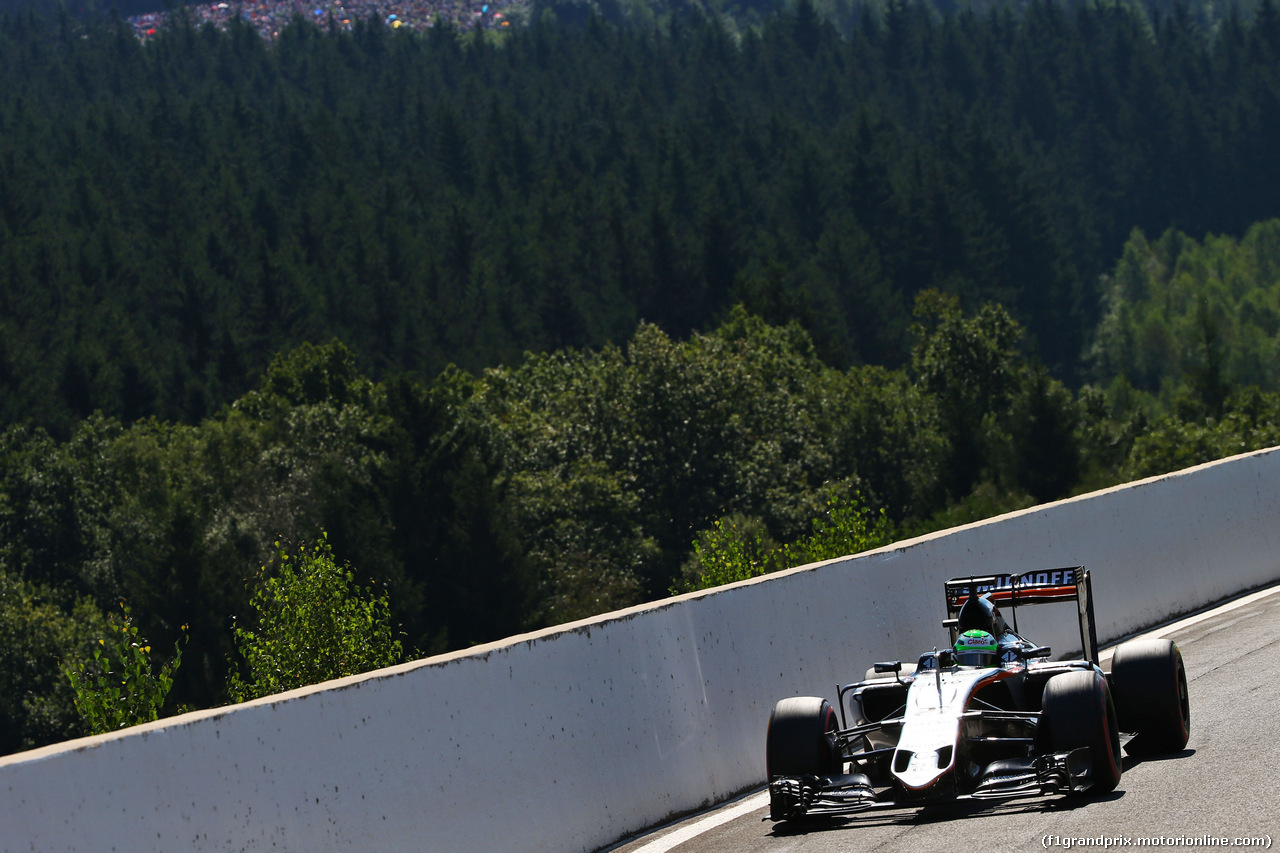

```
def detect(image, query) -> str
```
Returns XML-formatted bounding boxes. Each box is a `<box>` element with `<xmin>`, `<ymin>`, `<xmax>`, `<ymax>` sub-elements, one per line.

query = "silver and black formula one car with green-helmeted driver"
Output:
<box><xmin>765</xmin><ymin>566</ymin><xmax>1190</xmax><ymax>821</ymax></box>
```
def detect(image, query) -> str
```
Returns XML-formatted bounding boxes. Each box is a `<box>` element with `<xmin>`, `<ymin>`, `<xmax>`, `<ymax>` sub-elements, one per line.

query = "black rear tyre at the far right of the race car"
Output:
<box><xmin>1111</xmin><ymin>638</ymin><xmax>1192</xmax><ymax>754</ymax></box>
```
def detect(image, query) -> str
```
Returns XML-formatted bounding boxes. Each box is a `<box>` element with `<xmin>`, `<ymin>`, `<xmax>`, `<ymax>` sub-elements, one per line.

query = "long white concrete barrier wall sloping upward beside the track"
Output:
<box><xmin>0</xmin><ymin>451</ymin><xmax>1280</xmax><ymax>853</ymax></box>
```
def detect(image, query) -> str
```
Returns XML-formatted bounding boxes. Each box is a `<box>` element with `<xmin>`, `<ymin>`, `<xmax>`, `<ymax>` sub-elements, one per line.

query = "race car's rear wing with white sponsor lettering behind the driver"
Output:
<box><xmin>943</xmin><ymin>566</ymin><xmax>1098</xmax><ymax>663</ymax></box>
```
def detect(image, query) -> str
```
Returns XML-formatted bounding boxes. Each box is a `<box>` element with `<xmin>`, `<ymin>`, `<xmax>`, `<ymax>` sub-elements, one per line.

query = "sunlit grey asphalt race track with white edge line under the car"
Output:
<box><xmin>611</xmin><ymin>588</ymin><xmax>1280</xmax><ymax>853</ymax></box>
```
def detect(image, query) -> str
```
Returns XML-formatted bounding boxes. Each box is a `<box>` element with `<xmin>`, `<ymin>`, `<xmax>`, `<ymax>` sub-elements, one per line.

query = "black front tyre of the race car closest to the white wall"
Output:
<box><xmin>764</xmin><ymin>695</ymin><xmax>840</xmax><ymax>821</ymax></box>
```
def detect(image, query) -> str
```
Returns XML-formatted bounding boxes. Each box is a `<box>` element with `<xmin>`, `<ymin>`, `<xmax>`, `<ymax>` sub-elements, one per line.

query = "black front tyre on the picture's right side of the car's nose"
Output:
<box><xmin>1041</xmin><ymin>670</ymin><xmax>1124</xmax><ymax>794</ymax></box>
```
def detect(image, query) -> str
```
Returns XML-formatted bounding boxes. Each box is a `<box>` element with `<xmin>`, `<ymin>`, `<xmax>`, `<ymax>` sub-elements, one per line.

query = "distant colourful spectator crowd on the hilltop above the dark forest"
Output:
<box><xmin>129</xmin><ymin>0</ymin><xmax>525</xmax><ymax>41</ymax></box>
